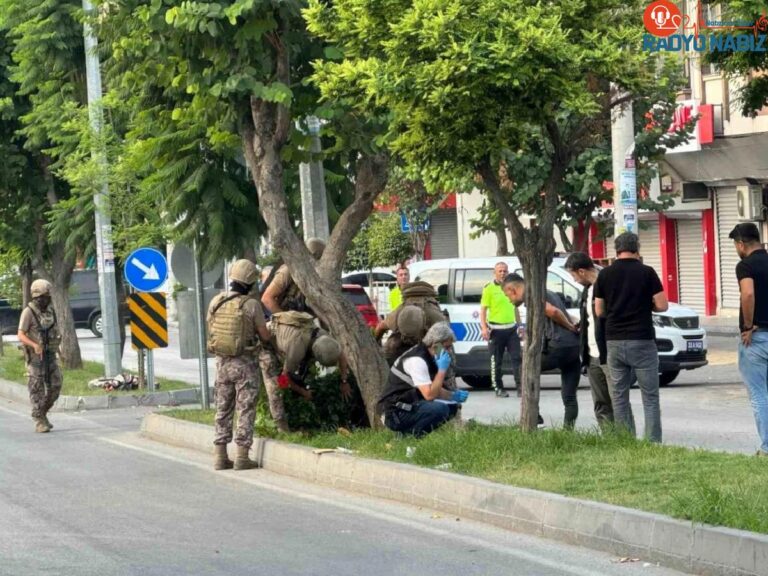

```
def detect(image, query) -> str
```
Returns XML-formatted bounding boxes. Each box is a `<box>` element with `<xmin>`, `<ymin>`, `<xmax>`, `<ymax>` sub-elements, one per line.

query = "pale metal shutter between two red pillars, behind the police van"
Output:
<box><xmin>677</xmin><ymin>220</ymin><xmax>706</xmax><ymax>314</ymax></box>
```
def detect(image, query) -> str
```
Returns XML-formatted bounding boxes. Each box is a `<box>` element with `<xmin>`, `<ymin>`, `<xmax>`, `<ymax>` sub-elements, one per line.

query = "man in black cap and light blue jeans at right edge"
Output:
<box><xmin>729</xmin><ymin>223</ymin><xmax>768</xmax><ymax>456</ymax></box>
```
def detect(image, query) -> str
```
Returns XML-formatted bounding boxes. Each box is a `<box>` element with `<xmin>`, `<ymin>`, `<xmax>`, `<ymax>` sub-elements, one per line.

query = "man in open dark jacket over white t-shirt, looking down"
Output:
<box><xmin>565</xmin><ymin>252</ymin><xmax>634</xmax><ymax>428</ymax></box>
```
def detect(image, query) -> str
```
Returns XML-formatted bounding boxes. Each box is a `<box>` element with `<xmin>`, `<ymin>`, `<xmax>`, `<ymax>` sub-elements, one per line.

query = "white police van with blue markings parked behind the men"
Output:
<box><xmin>409</xmin><ymin>256</ymin><xmax>707</xmax><ymax>388</ymax></box>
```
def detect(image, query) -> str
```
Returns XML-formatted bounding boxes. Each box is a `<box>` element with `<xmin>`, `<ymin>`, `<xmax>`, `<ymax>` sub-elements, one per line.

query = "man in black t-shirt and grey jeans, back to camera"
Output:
<box><xmin>595</xmin><ymin>232</ymin><xmax>669</xmax><ymax>442</ymax></box>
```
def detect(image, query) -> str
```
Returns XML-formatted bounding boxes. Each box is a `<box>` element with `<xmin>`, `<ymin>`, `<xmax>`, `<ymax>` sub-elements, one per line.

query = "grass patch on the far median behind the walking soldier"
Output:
<box><xmin>0</xmin><ymin>346</ymin><xmax>192</xmax><ymax>396</ymax></box>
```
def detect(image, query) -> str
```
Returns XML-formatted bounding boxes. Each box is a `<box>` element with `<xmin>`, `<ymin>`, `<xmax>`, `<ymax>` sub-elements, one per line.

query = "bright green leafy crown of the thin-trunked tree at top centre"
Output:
<box><xmin>306</xmin><ymin>0</ymin><xmax>652</xmax><ymax>181</ymax></box>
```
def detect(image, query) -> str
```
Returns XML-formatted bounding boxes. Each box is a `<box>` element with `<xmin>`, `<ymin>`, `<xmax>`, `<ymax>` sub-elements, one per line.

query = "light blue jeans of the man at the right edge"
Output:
<box><xmin>739</xmin><ymin>330</ymin><xmax>768</xmax><ymax>452</ymax></box>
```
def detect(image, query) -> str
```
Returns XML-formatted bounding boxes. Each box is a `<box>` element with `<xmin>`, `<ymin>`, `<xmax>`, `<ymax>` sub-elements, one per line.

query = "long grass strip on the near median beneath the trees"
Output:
<box><xmin>163</xmin><ymin>409</ymin><xmax>768</xmax><ymax>533</ymax></box>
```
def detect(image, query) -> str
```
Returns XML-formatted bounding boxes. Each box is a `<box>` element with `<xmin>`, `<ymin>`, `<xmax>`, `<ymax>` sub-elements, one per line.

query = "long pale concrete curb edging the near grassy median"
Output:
<box><xmin>141</xmin><ymin>414</ymin><xmax>768</xmax><ymax>576</ymax></box>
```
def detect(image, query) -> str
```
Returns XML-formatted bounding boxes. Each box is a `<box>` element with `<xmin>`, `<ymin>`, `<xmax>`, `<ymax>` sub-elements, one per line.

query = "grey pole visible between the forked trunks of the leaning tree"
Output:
<box><xmin>299</xmin><ymin>116</ymin><xmax>330</xmax><ymax>240</ymax></box>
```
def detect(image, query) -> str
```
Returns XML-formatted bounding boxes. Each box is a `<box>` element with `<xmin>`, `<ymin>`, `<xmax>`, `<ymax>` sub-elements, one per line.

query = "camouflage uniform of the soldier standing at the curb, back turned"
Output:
<box><xmin>208</xmin><ymin>292</ymin><xmax>266</xmax><ymax>447</ymax></box>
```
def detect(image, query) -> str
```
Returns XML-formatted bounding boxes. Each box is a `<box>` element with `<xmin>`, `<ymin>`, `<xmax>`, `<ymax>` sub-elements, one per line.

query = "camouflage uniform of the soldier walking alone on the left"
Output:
<box><xmin>19</xmin><ymin>300</ymin><xmax>62</xmax><ymax>420</ymax></box>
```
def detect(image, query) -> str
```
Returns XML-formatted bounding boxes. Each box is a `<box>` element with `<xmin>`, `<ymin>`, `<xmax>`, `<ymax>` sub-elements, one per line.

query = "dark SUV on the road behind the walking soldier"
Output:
<box><xmin>0</xmin><ymin>270</ymin><xmax>118</xmax><ymax>337</ymax></box>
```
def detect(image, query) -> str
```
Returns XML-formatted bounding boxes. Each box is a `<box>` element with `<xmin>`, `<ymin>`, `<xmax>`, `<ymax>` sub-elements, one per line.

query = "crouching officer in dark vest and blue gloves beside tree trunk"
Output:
<box><xmin>378</xmin><ymin>322</ymin><xmax>469</xmax><ymax>437</ymax></box>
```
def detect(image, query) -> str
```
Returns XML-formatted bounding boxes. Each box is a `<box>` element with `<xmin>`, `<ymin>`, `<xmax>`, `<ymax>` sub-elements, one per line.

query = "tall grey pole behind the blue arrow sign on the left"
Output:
<box><xmin>83</xmin><ymin>0</ymin><xmax>124</xmax><ymax>378</ymax></box>
